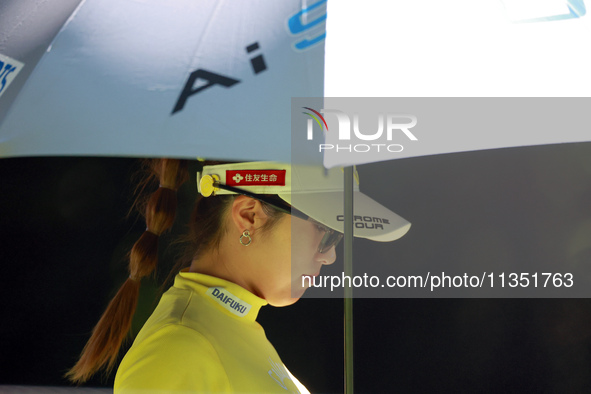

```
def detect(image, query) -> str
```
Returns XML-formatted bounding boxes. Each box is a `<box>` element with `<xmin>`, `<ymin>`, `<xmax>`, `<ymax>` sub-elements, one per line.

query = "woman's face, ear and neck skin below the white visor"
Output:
<box><xmin>197</xmin><ymin>196</ymin><xmax>336</xmax><ymax>306</ymax></box>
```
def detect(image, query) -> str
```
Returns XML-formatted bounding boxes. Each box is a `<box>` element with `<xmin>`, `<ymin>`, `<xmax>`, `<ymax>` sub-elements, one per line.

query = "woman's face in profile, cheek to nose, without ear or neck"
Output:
<box><xmin>252</xmin><ymin>211</ymin><xmax>336</xmax><ymax>306</ymax></box>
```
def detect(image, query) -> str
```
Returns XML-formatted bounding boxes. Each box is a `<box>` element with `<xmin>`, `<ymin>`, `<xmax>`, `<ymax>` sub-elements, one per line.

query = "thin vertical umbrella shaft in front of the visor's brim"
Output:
<box><xmin>344</xmin><ymin>167</ymin><xmax>354</xmax><ymax>394</ymax></box>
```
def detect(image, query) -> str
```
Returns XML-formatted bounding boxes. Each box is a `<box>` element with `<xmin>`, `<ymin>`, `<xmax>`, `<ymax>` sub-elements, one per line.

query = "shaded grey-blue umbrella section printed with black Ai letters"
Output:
<box><xmin>0</xmin><ymin>0</ymin><xmax>326</xmax><ymax>161</ymax></box>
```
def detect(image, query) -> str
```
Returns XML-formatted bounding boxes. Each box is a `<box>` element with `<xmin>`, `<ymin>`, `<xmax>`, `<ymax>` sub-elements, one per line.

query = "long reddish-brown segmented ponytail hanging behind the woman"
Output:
<box><xmin>66</xmin><ymin>159</ymin><xmax>189</xmax><ymax>383</ymax></box>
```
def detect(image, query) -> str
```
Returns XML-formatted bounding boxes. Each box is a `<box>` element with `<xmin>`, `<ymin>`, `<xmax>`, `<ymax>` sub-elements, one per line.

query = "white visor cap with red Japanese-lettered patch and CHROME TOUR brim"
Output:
<box><xmin>197</xmin><ymin>161</ymin><xmax>410</xmax><ymax>242</ymax></box>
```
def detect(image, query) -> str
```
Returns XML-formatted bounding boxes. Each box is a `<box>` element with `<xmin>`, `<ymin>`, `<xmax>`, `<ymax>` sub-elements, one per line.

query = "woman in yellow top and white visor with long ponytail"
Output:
<box><xmin>70</xmin><ymin>159</ymin><xmax>409</xmax><ymax>393</ymax></box>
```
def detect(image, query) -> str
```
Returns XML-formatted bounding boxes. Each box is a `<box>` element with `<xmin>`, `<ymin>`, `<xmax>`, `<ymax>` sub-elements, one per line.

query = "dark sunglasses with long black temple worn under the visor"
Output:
<box><xmin>213</xmin><ymin>181</ymin><xmax>343</xmax><ymax>253</ymax></box>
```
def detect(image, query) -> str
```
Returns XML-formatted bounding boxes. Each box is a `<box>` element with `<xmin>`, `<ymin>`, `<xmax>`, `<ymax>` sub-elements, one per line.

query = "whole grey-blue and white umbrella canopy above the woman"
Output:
<box><xmin>0</xmin><ymin>0</ymin><xmax>591</xmax><ymax>166</ymax></box>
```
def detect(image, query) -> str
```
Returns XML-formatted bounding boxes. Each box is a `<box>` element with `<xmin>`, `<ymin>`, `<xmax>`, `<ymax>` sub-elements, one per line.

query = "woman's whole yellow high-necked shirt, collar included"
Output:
<box><xmin>115</xmin><ymin>272</ymin><xmax>308</xmax><ymax>394</ymax></box>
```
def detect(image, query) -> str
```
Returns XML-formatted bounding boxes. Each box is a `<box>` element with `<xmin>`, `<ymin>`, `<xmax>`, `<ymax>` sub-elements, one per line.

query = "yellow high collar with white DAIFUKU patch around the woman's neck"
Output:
<box><xmin>174</xmin><ymin>269</ymin><xmax>268</xmax><ymax>321</ymax></box>
